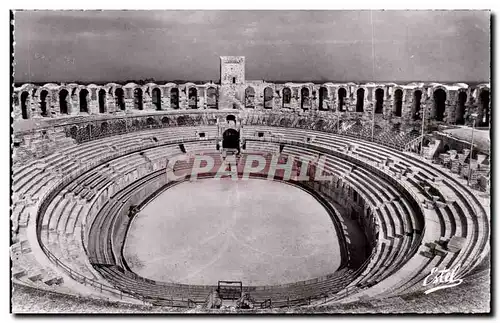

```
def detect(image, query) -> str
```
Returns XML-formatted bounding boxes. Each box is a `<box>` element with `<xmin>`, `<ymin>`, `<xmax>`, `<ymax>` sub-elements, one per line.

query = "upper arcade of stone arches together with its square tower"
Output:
<box><xmin>13</xmin><ymin>56</ymin><xmax>491</xmax><ymax>126</ymax></box>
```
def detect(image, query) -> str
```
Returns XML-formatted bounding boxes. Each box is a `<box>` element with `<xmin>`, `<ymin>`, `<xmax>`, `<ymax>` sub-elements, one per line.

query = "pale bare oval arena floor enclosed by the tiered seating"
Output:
<box><xmin>124</xmin><ymin>178</ymin><xmax>341</xmax><ymax>285</ymax></box>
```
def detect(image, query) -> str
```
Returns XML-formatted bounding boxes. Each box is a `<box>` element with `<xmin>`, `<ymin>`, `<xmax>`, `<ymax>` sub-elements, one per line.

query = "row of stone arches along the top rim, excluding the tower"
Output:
<box><xmin>15</xmin><ymin>84</ymin><xmax>491</xmax><ymax>126</ymax></box>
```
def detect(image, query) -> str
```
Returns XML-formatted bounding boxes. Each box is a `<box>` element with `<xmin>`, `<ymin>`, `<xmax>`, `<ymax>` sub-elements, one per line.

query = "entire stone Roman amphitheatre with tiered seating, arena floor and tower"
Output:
<box><xmin>10</xmin><ymin>56</ymin><xmax>491</xmax><ymax>313</ymax></box>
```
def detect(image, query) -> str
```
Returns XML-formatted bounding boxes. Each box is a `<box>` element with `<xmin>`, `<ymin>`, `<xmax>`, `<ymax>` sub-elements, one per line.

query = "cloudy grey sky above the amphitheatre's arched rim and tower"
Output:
<box><xmin>13</xmin><ymin>10</ymin><xmax>490</xmax><ymax>83</ymax></box>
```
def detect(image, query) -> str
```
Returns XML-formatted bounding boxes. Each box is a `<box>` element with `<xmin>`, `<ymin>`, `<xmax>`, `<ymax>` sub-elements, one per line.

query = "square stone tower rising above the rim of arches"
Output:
<box><xmin>219</xmin><ymin>56</ymin><xmax>245</xmax><ymax>109</ymax></box>
